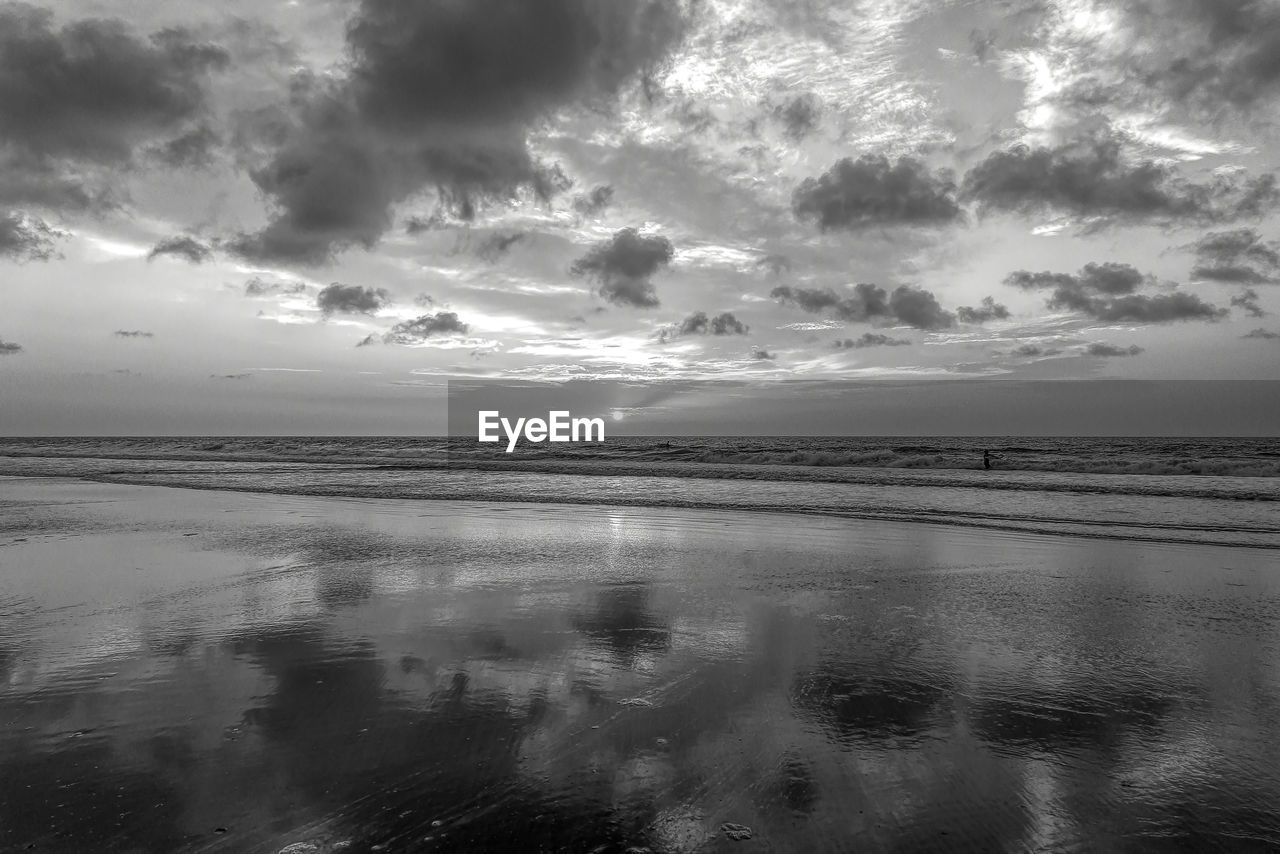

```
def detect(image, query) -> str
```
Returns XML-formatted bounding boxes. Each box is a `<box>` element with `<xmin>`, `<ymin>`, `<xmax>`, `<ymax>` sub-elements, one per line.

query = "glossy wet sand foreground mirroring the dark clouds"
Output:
<box><xmin>0</xmin><ymin>478</ymin><xmax>1280</xmax><ymax>854</ymax></box>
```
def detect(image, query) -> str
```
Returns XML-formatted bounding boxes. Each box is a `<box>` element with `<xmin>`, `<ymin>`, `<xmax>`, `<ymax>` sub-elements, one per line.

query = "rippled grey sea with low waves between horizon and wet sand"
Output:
<box><xmin>0</xmin><ymin>437</ymin><xmax>1280</xmax><ymax>549</ymax></box>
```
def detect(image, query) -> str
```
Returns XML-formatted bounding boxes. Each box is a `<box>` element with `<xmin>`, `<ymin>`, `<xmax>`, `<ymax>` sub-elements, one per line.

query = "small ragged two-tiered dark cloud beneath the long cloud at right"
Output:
<box><xmin>1005</xmin><ymin>258</ymin><xmax>1226</xmax><ymax>323</ymax></box>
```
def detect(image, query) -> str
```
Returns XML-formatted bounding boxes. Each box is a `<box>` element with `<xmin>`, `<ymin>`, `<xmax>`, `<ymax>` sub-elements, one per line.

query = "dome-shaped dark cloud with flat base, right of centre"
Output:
<box><xmin>791</xmin><ymin>155</ymin><xmax>963</xmax><ymax>232</ymax></box>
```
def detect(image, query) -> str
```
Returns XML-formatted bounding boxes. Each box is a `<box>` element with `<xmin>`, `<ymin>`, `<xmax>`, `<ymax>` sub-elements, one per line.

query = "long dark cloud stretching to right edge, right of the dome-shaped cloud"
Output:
<box><xmin>960</xmin><ymin>137</ymin><xmax>1280</xmax><ymax>223</ymax></box>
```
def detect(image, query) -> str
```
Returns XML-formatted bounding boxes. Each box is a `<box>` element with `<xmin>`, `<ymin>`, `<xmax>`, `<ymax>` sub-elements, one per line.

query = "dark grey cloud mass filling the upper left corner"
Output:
<box><xmin>0</xmin><ymin>3</ymin><xmax>229</xmax><ymax>218</ymax></box>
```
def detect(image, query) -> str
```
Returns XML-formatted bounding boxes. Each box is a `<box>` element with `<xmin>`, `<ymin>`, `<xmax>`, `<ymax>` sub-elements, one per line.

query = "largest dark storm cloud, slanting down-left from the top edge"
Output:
<box><xmin>236</xmin><ymin>0</ymin><xmax>684</xmax><ymax>262</ymax></box>
